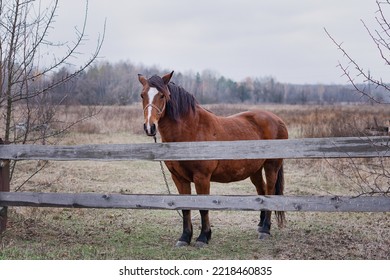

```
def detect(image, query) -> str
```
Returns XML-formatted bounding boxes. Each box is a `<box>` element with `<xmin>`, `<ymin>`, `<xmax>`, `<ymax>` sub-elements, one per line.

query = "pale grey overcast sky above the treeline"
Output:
<box><xmin>45</xmin><ymin>0</ymin><xmax>390</xmax><ymax>84</ymax></box>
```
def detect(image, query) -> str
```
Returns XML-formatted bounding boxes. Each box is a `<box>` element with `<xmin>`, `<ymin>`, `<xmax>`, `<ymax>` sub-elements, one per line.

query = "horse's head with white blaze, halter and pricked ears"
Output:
<box><xmin>138</xmin><ymin>71</ymin><xmax>173</xmax><ymax>136</ymax></box>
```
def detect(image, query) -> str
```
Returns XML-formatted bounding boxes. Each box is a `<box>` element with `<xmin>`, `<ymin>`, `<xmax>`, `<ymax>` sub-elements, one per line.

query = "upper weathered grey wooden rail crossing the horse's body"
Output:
<box><xmin>0</xmin><ymin>137</ymin><xmax>390</xmax><ymax>161</ymax></box>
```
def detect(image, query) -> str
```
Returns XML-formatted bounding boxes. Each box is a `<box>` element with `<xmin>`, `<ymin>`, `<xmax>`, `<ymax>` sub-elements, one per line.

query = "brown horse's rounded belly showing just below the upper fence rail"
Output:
<box><xmin>211</xmin><ymin>160</ymin><xmax>264</xmax><ymax>183</ymax></box>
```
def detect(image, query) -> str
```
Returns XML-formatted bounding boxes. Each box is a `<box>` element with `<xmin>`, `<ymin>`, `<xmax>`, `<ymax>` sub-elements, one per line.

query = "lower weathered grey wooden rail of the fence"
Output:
<box><xmin>0</xmin><ymin>192</ymin><xmax>390</xmax><ymax>212</ymax></box>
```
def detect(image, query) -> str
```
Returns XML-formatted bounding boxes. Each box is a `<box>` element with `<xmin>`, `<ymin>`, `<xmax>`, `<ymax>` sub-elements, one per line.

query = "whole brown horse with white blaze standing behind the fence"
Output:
<box><xmin>138</xmin><ymin>71</ymin><xmax>288</xmax><ymax>247</ymax></box>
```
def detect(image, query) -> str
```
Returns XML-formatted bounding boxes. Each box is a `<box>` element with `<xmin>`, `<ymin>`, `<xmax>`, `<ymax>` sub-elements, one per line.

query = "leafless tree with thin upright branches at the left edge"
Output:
<box><xmin>0</xmin><ymin>0</ymin><xmax>105</xmax><ymax>188</ymax></box>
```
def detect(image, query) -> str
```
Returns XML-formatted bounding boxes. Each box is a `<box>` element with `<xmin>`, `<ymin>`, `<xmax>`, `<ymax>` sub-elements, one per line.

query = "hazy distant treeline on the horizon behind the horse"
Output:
<box><xmin>40</xmin><ymin>62</ymin><xmax>390</xmax><ymax>105</ymax></box>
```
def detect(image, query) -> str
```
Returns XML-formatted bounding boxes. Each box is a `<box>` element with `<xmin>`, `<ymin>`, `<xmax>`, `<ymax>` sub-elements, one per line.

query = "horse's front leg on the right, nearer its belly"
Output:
<box><xmin>194</xmin><ymin>176</ymin><xmax>211</xmax><ymax>247</ymax></box>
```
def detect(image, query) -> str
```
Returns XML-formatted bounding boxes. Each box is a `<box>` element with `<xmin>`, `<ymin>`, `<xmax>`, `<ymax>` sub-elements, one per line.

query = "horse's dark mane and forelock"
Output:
<box><xmin>148</xmin><ymin>75</ymin><xmax>198</xmax><ymax>121</ymax></box>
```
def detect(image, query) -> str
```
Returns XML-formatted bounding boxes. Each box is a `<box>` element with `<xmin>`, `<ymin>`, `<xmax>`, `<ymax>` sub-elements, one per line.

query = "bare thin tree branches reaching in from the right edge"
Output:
<box><xmin>325</xmin><ymin>0</ymin><xmax>390</xmax><ymax>195</ymax></box>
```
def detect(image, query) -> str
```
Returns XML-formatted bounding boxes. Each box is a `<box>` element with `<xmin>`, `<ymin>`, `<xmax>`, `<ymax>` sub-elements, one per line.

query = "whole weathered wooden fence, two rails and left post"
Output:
<box><xmin>0</xmin><ymin>137</ymin><xmax>390</xmax><ymax>231</ymax></box>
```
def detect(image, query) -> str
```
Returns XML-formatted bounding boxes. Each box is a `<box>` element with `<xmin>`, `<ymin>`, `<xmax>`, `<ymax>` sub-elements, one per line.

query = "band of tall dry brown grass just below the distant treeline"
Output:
<box><xmin>44</xmin><ymin>104</ymin><xmax>390</xmax><ymax>138</ymax></box>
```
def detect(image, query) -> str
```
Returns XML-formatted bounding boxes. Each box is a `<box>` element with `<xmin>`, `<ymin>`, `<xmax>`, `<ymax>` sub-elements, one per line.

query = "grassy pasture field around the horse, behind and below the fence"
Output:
<box><xmin>0</xmin><ymin>105</ymin><xmax>390</xmax><ymax>259</ymax></box>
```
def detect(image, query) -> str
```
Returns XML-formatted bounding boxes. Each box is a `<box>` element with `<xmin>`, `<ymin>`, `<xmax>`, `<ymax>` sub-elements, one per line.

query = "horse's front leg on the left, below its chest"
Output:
<box><xmin>172</xmin><ymin>174</ymin><xmax>193</xmax><ymax>247</ymax></box>
